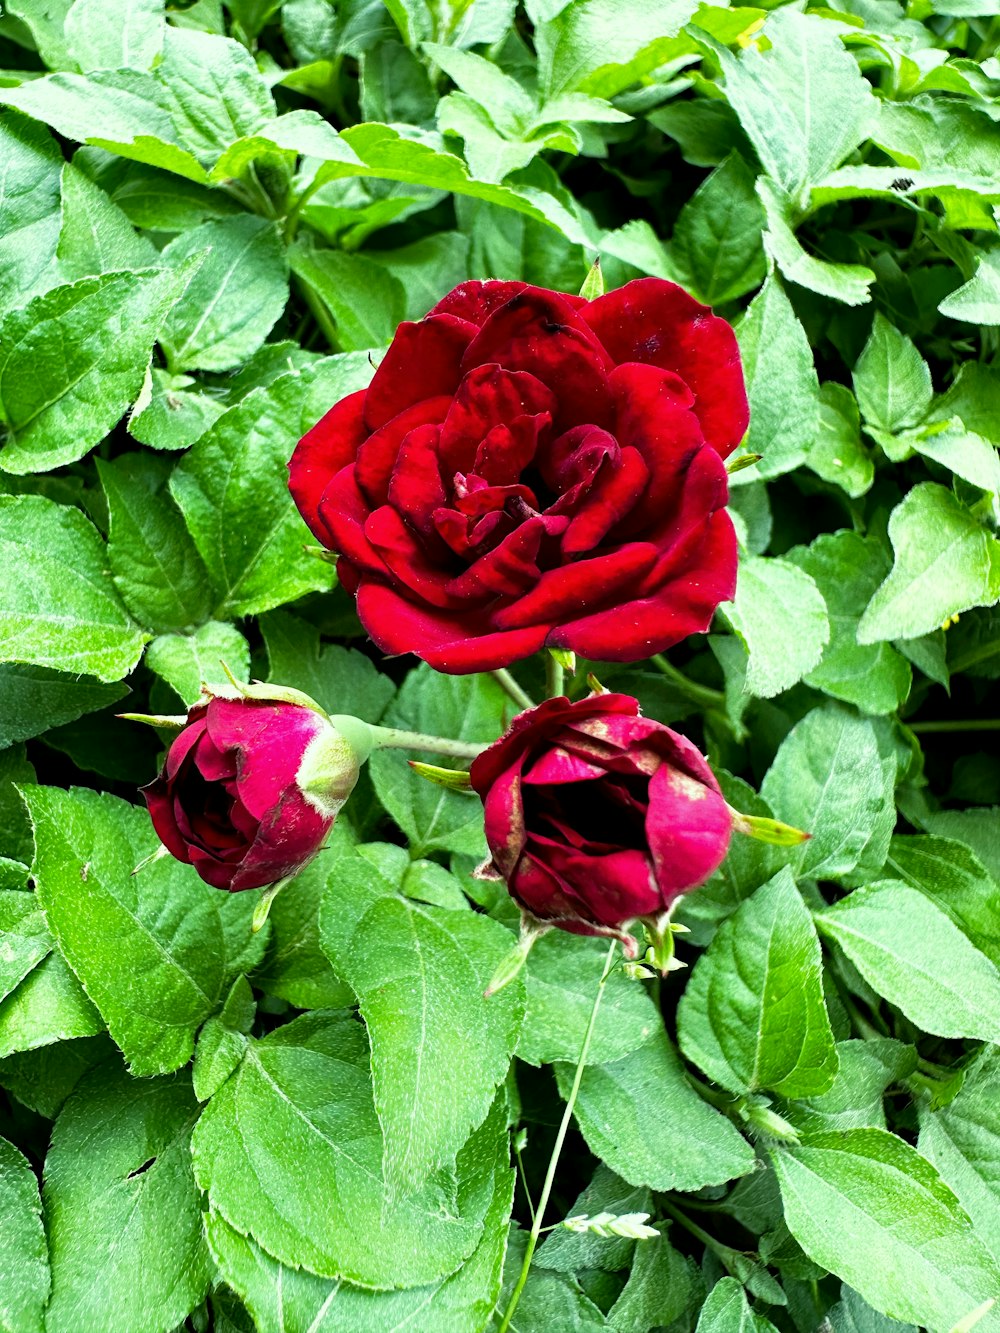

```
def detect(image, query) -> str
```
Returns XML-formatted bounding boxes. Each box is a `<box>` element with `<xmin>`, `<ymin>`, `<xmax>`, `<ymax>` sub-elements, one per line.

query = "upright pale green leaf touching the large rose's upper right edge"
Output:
<box><xmin>733</xmin><ymin>273</ymin><xmax>820</xmax><ymax>485</ymax></box>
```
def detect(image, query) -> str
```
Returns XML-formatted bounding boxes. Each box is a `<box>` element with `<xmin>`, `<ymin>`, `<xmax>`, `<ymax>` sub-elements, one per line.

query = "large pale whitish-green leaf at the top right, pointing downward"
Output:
<box><xmin>713</xmin><ymin>9</ymin><xmax>877</xmax><ymax>203</ymax></box>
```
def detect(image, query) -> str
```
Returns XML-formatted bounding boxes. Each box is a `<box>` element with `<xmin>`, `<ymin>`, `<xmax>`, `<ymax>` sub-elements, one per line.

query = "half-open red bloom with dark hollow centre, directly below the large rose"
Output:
<box><xmin>471</xmin><ymin>694</ymin><xmax>732</xmax><ymax>934</ymax></box>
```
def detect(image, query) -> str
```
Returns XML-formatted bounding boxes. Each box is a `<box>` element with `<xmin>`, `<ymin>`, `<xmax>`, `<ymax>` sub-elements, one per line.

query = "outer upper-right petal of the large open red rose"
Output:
<box><xmin>580</xmin><ymin>277</ymin><xmax>749</xmax><ymax>459</ymax></box>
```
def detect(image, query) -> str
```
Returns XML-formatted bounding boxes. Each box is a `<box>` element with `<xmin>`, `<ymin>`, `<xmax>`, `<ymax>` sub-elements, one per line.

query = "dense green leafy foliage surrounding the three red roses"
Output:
<box><xmin>0</xmin><ymin>0</ymin><xmax>1000</xmax><ymax>1333</ymax></box>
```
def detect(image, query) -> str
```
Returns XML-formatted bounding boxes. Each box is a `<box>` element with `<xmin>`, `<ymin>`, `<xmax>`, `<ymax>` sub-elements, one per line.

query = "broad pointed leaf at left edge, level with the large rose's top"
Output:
<box><xmin>0</xmin><ymin>269</ymin><xmax>189</xmax><ymax>475</ymax></box>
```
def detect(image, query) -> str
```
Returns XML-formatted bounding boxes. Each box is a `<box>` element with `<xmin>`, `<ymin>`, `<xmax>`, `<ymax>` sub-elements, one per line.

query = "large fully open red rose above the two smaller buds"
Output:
<box><xmin>289</xmin><ymin>277</ymin><xmax>747</xmax><ymax>672</ymax></box>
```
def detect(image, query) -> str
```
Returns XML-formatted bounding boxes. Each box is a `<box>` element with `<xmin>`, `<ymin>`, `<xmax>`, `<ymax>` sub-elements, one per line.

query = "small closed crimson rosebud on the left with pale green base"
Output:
<box><xmin>143</xmin><ymin>686</ymin><xmax>371</xmax><ymax>892</ymax></box>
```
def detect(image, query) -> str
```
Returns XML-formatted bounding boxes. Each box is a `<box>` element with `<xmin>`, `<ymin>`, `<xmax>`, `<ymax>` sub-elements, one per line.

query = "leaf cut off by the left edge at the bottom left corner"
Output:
<box><xmin>0</xmin><ymin>1138</ymin><xmax>51</xmax><ymax>1333</ymax></box>
